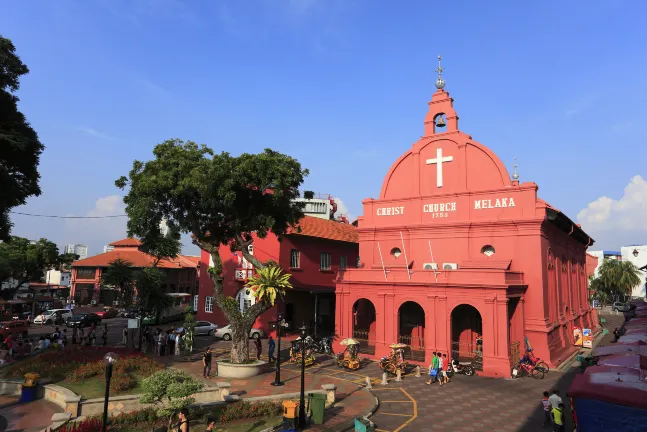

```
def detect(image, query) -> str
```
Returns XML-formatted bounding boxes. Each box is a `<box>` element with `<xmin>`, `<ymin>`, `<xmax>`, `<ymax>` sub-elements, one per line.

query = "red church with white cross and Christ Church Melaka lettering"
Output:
<box><xmin>335</xmin><ymin>66</ymin><xmax>597</xmax><ymax>377</ymax></box>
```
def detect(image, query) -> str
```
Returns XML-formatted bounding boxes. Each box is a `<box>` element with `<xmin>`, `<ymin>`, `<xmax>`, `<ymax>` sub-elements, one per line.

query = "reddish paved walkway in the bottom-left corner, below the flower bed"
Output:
<box><xmin>0</xmin><ymin>396</ymin><xmax>63</xmax><ymax>432</ymax></box>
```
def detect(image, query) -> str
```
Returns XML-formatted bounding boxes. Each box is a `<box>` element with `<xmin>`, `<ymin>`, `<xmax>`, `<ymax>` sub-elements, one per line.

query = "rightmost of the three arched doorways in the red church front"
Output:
<box><xmin>451</xmin><ymin>304</ymin><xmax>483</xmax><ymax>370</ymax></box>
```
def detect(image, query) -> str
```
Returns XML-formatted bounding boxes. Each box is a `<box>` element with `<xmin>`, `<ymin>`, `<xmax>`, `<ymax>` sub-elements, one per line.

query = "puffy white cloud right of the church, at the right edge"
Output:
<box><xmin>577</xmin><ymin>175</ymin><xmax>647</xmax><ymax>249</ymax></box>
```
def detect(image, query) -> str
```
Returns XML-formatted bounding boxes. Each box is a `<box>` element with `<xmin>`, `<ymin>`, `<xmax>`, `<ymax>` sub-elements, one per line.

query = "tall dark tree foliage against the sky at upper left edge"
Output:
<box><xmin>0</xmin><ymin>35</ymin><xmax>44</xmax><ymax>240</ymax></box>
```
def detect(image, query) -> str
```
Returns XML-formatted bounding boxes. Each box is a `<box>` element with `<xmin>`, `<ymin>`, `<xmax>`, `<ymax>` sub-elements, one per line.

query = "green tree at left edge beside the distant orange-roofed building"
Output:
<box><xmin>0</xmin><ymin>237</ymin><xmax>79</xmax><ymax>297</ymax></box>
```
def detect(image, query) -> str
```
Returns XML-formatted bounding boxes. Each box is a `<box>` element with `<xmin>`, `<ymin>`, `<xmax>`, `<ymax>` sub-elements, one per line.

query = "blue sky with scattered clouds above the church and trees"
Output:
<box><xmin>0</xmin><ymin>0</ymin><xmax>647</xmax><ymax>253</ymax></box>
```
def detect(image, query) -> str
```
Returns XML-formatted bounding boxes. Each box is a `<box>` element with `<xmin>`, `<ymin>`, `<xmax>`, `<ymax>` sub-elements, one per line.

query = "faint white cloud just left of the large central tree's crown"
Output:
<box><xmin>63</xmin><ymin>195</ymin><xmax>128</xmax><ymax>255</ymax></box>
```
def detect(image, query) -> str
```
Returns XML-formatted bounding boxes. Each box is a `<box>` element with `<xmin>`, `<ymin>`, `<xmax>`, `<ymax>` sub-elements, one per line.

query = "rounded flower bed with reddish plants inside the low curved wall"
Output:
<box><xmin>8</xmin><ymin>347</ymin><xmax>164</xmax><ymax>397</ymax></box>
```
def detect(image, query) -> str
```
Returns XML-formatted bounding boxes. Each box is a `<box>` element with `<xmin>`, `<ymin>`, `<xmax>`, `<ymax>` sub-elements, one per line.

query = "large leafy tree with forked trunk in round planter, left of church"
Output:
<box><xmin>116</xmin><ymin>140</ymin><xmax>308</xmax><ymax>363</ymax></box>
